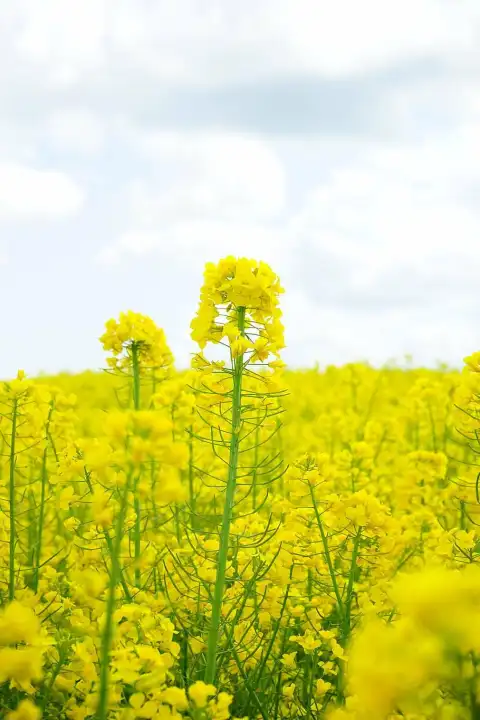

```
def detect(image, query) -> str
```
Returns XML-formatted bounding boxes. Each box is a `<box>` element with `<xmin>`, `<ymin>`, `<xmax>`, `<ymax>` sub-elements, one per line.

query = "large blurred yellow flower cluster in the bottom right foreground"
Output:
<box><xmin>349</xmin><ymin>565</ymin><xmax>480</xmax><ymax>720</ymax></box>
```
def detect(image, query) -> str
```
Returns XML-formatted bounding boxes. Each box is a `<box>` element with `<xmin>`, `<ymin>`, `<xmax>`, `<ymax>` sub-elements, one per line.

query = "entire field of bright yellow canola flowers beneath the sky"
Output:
<box><xmin>0</xmin><ymin>257</ymin><xmax>480</xmax><ymax>720</ymax></box>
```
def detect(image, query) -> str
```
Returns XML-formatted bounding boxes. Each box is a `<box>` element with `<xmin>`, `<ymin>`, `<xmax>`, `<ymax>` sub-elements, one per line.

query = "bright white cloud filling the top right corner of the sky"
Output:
<box><xmin>268</xmin><ymin>0</ymin><xmax>480</xmax><ymax>76</ymax></box>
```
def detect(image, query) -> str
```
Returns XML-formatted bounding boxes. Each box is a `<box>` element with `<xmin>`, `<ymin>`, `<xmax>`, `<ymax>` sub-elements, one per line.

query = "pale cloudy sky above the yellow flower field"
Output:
<box><xmin>0</xmin><ymin>0</ymin><xmax>480</xmax><ymax>377</ymax></box>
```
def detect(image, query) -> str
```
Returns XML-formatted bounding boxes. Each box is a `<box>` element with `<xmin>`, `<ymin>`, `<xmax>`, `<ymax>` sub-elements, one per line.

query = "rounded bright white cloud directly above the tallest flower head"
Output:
<box><xmin>133</xmin><ymin>132</ymin><xmax>286</xmax><ymax>220</ymax></box>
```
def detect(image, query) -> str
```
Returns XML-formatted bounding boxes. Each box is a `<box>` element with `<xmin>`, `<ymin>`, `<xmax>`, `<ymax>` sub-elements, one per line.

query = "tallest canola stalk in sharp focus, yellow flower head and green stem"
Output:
<box><xmin>188</xmin><ymin>257</ymin><xmax>283</xmax><ymax>684</ymax></box>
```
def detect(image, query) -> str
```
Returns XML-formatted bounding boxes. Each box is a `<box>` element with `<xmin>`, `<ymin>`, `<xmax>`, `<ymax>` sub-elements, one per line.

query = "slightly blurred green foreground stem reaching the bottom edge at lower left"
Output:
<box><xmin>97</xmin><ymin>481</ymin><xmax>129</xmax><ymax>720</ymax></box>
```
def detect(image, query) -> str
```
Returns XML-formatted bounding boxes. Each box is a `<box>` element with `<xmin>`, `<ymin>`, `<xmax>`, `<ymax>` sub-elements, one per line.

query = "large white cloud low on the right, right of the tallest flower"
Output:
<box><xmin>276</xmin><ymin>117</ymin><xmax>480</xmax><ymax>364</ymax></box>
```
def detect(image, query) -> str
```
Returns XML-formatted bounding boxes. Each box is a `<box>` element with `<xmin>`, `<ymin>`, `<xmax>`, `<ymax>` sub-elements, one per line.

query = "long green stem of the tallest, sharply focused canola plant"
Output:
<box><xmin>205</xmin><ymin>307</ymin><xmax>245</xmax><ymax>684</ymax></box>
